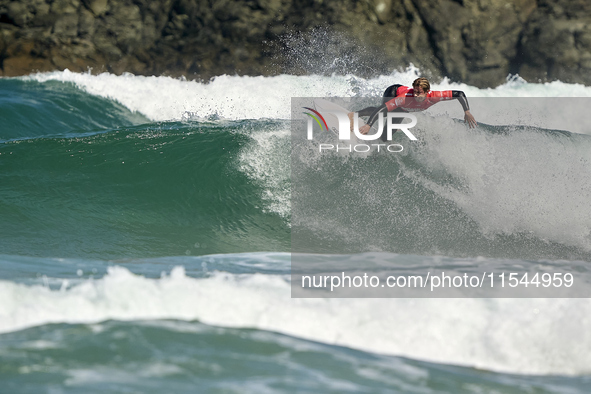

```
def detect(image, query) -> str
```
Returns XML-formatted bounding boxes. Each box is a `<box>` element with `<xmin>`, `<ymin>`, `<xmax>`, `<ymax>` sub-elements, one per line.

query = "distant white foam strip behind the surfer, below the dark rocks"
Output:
<box><xmin>24</xmin><ymin>66</ymin><xmax>591</xmax><ymax>124</ymax></box>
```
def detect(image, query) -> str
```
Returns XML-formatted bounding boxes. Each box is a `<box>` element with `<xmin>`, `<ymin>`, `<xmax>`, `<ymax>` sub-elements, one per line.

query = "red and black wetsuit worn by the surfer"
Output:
<box><xmin>359</xmin><ymin>85</ymin><xmax>470</xmax><ymax>141</ymax></box>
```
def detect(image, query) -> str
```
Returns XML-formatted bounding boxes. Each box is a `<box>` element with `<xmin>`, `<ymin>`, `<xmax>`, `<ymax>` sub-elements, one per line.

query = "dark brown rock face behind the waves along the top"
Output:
<box><xmin>0</xmin><ymin>0</ymin><xmax>591</xmax><ymax>87</ymax></box>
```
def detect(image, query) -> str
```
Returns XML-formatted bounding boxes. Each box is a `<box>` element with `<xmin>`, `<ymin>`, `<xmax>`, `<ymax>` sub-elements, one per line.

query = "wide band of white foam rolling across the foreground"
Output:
<box><xmin>0</xmin><ymin>267</ymin><xmax>591</xmax><ymax>374</ymax></box>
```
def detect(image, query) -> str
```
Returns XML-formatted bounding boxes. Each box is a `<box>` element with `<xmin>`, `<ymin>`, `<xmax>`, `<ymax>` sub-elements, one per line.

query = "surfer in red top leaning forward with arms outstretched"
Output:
<box><xmin>349</xmin><ymin>78</ymin><xmax>477</xmax><ymax>141</ymax></box>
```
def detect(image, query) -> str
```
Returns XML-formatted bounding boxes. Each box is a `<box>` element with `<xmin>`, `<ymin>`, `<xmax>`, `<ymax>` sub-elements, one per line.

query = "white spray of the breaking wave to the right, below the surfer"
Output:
<box><xmin>405</xmin><ymin>112</ymin><xmax>591</xmax><ymax>250</ymax></box>
